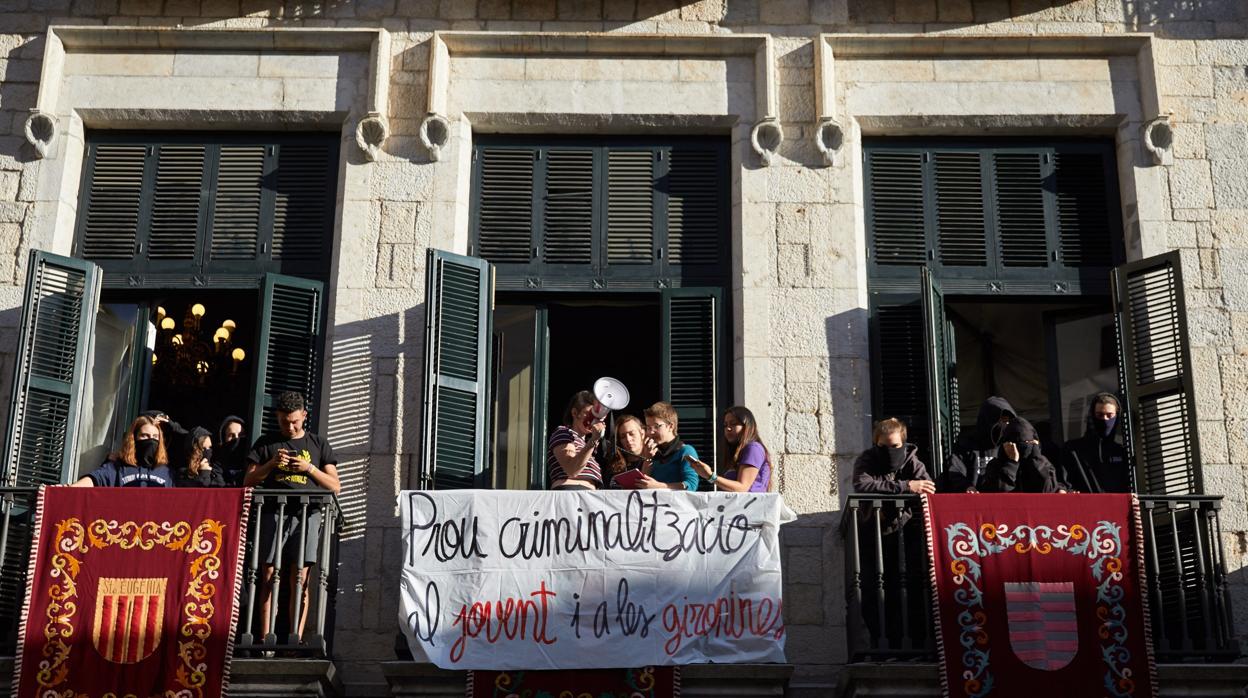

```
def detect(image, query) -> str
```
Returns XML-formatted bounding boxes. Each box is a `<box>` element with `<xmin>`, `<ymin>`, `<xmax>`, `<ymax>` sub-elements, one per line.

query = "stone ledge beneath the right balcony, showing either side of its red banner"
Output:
<box><xmin>836</xmin><ymin>662</ymin><xmax>1248</xmax><ymax>698</ymax></box>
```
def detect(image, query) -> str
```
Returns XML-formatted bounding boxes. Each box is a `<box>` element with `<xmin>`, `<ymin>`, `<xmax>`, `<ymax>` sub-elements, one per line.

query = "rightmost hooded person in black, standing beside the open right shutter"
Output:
<box><xmin>1061</xmin><ymin>392</ymin><xmax>1131</xmax><ymax>494</ymax></box>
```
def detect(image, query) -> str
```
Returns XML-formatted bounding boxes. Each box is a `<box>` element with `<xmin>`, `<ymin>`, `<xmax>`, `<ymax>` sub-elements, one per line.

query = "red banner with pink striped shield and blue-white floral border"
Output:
<box><xmin>924</xmin><ymin>493</ymin><xmax>1157</xmax><ymax>698</ymax></box>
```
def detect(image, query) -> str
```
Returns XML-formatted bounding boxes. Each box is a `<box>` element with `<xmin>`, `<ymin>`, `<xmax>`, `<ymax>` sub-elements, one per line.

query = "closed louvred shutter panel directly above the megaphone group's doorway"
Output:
<box><xmin>469</xmin><ymin>137</ymin><xmax>731</xmax><ymax>290</ymax></box>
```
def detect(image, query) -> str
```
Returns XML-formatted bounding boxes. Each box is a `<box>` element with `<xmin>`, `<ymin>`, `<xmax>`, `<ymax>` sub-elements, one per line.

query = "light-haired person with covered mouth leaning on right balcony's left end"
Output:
<box><xmin>852</xmin><ymin>418</ymin><xmax>936</xmax><ymax>649</ymax></box>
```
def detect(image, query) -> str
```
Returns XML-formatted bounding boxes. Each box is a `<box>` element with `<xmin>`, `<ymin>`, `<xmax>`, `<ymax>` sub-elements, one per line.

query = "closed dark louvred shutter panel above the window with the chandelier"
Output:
<box><xmin>75</xmin><ymin>134</ymin><xmax>338</xmax><ymax>287</ymax></box>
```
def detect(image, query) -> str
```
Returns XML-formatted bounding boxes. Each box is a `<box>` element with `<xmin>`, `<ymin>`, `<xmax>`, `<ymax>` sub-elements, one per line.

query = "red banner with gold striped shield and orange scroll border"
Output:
<box><xmin>14</xmin><ymin>487</ymin><xmax>250</xmax><ymax>698</ymax></box>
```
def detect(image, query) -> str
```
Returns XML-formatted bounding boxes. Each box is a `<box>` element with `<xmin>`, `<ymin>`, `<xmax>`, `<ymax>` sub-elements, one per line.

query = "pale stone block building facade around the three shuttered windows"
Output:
<box><xmin>0</xmin><ymin>0</ymin><xmax>1248</xmax><ymax>696</ymax></box>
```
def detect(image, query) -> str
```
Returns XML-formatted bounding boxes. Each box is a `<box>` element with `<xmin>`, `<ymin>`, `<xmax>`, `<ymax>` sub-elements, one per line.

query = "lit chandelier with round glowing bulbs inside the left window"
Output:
<box><xmin>152</xmin><ymin>303</ymin><xmax>247</xmax><ymax>387</ymax></box>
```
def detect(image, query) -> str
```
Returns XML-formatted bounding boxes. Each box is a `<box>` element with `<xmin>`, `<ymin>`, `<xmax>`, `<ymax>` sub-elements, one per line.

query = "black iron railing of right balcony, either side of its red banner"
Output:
<box><xmin>841</xmin><ymin>494</ymin><xmax>1239</xmax><ymax>662</ymax></box>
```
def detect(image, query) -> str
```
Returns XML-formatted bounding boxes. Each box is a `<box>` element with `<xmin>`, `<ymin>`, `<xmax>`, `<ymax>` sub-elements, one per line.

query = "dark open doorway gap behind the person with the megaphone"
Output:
<box><xmin>547</xmin><ymin>300</ymin><xmax>663</xmax><ymax>428</ymax></box>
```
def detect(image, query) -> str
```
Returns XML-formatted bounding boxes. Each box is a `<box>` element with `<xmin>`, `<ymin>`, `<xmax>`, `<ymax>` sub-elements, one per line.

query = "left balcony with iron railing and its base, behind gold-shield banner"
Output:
<box><xmin>0</xmin><ymin>488</ymin><xmax>342</xmax><ymax>697</ymax></box>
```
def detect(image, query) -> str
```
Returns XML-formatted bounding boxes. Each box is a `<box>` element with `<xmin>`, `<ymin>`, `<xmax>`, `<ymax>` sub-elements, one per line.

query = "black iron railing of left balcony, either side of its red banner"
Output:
<box><xmin>0</xmin><ymin>487</ymin><xmax>342</xmax><ymax>658</ymax></box>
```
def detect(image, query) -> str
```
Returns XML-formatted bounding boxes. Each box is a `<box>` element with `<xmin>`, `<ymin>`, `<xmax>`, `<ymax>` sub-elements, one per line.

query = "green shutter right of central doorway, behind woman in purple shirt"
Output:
<box><xmin>661</xmin><ymin>288</ymin><xmax>723</xmax><ymax>471</ymax></box>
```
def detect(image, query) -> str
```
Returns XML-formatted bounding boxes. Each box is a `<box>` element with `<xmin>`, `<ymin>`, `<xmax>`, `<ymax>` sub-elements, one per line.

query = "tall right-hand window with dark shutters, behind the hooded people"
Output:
<box><xmin>864</xmin><ymin>140</ymin><xmax>1202</xmax><ymax>494</ymax></box>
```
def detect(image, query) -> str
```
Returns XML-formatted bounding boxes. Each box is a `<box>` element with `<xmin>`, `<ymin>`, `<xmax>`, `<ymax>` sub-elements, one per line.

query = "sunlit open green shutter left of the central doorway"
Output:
<box><xmin>421</xmin><ymin>248</ymin><xmax>494</xmax><ymax>489</ymax></box>
